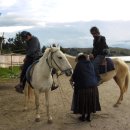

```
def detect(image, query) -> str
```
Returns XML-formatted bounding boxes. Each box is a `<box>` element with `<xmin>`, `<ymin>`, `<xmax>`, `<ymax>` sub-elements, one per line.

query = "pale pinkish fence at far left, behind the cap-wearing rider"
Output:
<box><xmin>0</xmin><ymin>54</ymin><xmax>25</xmax><ymax>68</ymax></box>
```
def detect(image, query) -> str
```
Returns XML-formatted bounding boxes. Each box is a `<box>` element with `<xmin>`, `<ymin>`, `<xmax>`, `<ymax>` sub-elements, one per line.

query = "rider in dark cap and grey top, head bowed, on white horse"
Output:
<box><xmin>15</xmin><ymin>31</ymin><xmax>42</xmax><ymax>93</ymax></box>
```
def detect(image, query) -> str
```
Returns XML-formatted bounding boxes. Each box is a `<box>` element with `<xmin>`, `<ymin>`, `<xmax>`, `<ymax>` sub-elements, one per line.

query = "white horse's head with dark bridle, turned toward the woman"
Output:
<box><xmin>45</xmin><ymin>46</ymin><xmax>72</xmax><ymax>76</ymax></box>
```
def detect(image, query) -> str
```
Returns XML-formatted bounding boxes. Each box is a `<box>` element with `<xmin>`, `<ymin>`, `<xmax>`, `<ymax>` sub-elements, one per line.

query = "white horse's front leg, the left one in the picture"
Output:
<box><xmin>34</xmin><ymin>90</ymin><xmax>40</xmax><ymax>122</ymax></box>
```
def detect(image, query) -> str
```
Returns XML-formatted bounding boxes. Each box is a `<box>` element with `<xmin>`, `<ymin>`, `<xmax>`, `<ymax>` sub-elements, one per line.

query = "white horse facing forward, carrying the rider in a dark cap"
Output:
<box><xmin>24</xmin><ymin>47</ymin><xmax>72</xmax><ymax>123</ymax></box>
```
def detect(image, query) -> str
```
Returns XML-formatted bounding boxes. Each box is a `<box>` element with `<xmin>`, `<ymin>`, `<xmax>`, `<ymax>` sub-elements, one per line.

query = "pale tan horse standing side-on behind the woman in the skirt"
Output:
<box><xmin>66</xmin><ymin>54</ymin><xmax>130</xmax><ymax>107</ymax></box>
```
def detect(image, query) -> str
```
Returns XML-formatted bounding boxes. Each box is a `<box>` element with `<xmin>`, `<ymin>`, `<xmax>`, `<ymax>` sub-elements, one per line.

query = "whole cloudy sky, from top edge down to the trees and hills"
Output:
<box><xmin>0</xmin><ymin>0</ymin><xmax>130</xmax><ymax>47</ymax></box>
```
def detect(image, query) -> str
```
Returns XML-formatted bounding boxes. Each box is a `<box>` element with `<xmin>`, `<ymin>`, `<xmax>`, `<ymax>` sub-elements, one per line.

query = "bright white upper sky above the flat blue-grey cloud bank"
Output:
<box><xmin>0</xmin><ymin>0</ymin><xmax>130</xmax><ymax>47</ymax></box>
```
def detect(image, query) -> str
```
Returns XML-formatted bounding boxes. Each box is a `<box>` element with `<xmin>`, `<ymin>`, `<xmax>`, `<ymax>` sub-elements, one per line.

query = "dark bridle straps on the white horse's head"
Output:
<box><xmin>46</xmin><ymin>50</ymin><xmax>72</xmax><ymax>76</ymax></box>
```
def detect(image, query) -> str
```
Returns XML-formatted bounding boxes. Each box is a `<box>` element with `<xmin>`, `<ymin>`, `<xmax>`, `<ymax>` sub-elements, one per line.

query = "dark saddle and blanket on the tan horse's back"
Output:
<box><xmin>99</xmin><ymin>58</ymin><xmax>115</xmax><ymax>74</ymax></box>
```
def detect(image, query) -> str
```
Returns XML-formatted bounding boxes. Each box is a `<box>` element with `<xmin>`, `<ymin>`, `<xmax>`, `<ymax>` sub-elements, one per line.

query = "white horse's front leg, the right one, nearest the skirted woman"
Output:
<box><xmin>45</xmin><ymin>90</ymin><xmax>52</xmax><ymax>123</ymax></box>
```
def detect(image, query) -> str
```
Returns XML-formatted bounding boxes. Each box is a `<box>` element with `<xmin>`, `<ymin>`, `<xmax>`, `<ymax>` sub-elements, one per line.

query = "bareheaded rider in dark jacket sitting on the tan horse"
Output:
<box><xmin>90</xmin><ymin>27</ymin><xmax>109</xmax><ymax>81</ymax></box>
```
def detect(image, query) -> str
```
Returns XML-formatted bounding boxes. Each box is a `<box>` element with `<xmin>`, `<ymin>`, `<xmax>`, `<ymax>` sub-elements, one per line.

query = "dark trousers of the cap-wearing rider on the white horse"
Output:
<box><xmin>20</xmin><ymin>57</ymin><xmax>34</xmax><ymax>89</ymax></box>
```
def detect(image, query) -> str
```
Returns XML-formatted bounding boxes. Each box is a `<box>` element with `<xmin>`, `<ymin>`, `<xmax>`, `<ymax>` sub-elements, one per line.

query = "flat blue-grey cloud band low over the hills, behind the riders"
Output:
<box><xmin>0</xmin><ymin>21</ymin><xmax>130</xmax><ymax>48</ymax></box>
